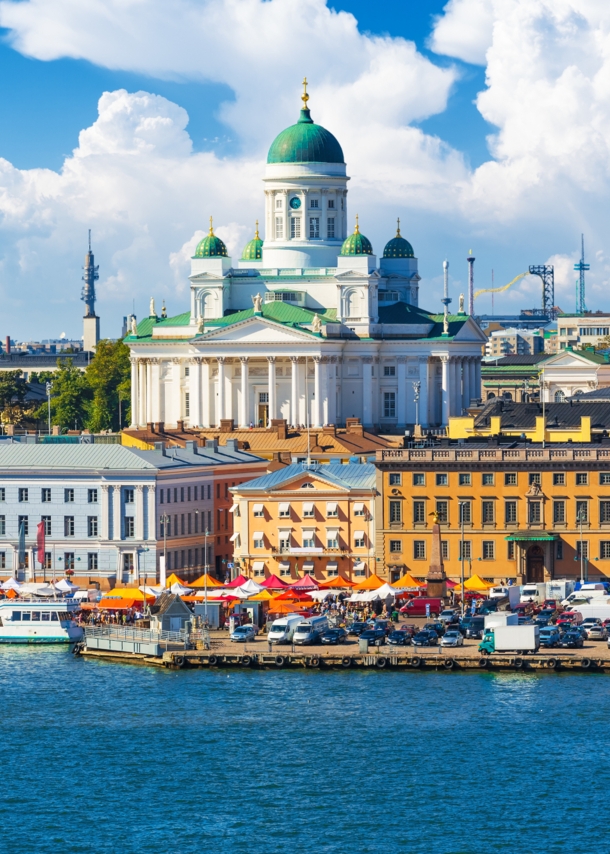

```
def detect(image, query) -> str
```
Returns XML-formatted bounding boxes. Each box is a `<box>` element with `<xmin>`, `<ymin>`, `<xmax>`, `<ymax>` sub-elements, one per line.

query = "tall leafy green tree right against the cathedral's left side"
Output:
<box><xmin>85</xmin><ymin>340</ymin><xmax>131</xmax><ymax>433</ymax></box>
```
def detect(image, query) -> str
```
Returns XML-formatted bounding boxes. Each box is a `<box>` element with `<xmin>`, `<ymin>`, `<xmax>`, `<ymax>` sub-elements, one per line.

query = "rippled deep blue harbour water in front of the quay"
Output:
<box><xmin>0</xmin><ymin>648</ymin><xmax>610</xmax><ymax>854</ymax></box>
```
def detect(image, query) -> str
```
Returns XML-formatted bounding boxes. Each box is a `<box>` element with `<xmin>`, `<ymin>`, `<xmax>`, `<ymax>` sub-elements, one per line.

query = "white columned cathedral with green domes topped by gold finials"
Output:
<box><xmin>125</xmin><ymin>83</ymin><xmax>486</xmax><ymax>433</ymax></box>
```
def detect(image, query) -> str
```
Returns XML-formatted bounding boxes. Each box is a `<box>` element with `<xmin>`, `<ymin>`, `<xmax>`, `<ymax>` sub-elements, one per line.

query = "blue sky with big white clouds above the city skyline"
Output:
<box><xmin>0</xmin><ymin>0</ymin><xmax>610</xmax><ymax>340</ymax></box>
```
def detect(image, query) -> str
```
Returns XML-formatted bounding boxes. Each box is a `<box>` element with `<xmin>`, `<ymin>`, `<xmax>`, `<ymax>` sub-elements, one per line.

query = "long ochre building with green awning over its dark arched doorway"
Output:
<box><xmin>376</xmin><ymin>442</ymin><xmax>610</xmax><ymax>583</ymax></box>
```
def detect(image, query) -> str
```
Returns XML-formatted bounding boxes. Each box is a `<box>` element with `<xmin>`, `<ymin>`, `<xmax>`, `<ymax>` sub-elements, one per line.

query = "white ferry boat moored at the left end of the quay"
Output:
<box><xmin>0</xmin><ymin>599</ymin><xmax>83</xmax><ymax>643</ymax></box>
